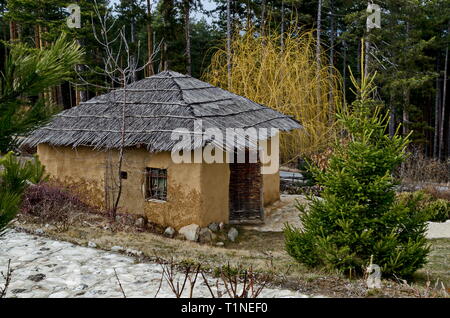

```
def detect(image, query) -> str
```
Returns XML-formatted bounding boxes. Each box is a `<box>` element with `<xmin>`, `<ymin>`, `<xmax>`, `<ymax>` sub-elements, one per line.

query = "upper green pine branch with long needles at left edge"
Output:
<box><xmin>0</xmin><ymin>34</ymin><xmax>83</xmax><ymax>153</ymax></box>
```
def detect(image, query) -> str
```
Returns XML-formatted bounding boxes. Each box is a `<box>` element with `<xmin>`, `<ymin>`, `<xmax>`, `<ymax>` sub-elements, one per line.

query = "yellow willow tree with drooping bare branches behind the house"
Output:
<box><xmin>203</xmin><ymin>27</ymin><xmax>341</xmax><ymax>163</ymax></box>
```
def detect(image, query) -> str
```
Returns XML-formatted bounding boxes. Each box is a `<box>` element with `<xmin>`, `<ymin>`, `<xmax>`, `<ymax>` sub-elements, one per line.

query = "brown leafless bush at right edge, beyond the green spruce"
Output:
<box><xmin>398</xmin><ymin>147</ymin><xmax>450</xmax><ymax>183</ymax></box>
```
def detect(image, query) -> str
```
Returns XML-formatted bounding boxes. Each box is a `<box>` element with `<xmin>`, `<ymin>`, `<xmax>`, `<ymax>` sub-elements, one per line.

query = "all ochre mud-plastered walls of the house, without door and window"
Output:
<box><xmin>38</xmin><ymin>137</ymin><xmax>280</xmax><ymax>229</ymax></box>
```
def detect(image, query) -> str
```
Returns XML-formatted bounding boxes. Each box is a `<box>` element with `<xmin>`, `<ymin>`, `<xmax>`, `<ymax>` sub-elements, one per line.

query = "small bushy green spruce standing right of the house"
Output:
<box><xmin>284</xmin><ymin>70</ymin><xmax>429</xmax><ymax>277</ymax></box>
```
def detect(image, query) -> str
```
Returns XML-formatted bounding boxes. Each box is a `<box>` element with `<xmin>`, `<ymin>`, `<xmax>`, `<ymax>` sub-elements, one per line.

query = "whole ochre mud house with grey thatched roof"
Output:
<box><xmin>24</xmin><ymin>71</ymin><xmax>301</xmax><ymax>229</ymax></box>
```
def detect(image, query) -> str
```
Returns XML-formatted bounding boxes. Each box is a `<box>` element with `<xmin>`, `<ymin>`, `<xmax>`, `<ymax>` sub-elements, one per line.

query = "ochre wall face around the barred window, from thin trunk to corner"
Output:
<box><xmin>103</xmin><ymin>148</ymin><xmax>201</xmax><ymax>229</ymax></box>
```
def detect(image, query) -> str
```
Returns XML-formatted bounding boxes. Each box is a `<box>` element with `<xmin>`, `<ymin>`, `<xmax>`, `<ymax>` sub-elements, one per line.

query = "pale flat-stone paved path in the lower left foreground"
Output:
<box><xmin>0</xmin><ymin>230</ymin><xmax>307</xmax><ymax>298</ymax></box>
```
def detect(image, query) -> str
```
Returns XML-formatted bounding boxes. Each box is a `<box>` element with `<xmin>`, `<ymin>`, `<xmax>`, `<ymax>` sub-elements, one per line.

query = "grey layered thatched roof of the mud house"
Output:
<box><xmin>23</xmin><ymin>71</ymin><xmax>301</xmax><ymax>152</ymax></box>
